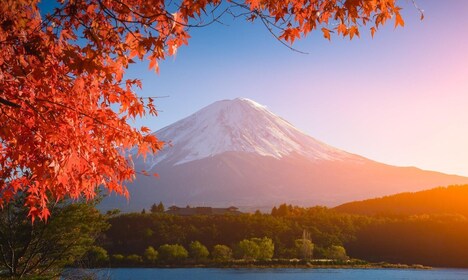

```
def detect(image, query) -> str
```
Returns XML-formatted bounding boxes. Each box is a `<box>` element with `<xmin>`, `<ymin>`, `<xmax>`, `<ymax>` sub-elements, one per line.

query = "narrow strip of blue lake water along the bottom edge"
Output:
<box><xmin>65</xmin><ymin>268</ymin><xmax>468</xmax><ymax>280</ymax></box>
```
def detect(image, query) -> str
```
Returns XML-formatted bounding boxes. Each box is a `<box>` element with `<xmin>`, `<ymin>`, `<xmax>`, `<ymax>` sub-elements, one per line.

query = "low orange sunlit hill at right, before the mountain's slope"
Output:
<box><xmin>334</xmin><ymin>185</ymin><xmax>468</xmax><ymax>218</ymax></box>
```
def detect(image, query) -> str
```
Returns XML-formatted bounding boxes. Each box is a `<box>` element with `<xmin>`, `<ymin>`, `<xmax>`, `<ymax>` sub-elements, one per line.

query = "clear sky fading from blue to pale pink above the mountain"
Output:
<box><xmin>127</xmin><ymin>0</ymin><xmax>468</xmax><ymax>176</ymax></box>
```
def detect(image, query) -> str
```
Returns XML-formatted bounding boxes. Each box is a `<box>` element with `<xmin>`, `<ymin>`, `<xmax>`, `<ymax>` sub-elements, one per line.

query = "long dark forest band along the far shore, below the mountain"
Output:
<box><xmin>99</xmin><ymin>199</ymin><xmax>468</xmax><ymax>267</ymax></box>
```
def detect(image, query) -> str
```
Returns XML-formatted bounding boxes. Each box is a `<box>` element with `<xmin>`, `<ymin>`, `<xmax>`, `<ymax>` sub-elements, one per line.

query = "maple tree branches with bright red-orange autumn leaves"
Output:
<box><xmin>0</xmin><ymin>0</ymin><xmax>410</xmax><ymax>219</ymax></box>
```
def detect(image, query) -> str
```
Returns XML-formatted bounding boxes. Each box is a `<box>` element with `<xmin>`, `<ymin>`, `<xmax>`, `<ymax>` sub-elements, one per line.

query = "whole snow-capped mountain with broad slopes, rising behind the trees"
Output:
<box><xmin>101</xmin><ymin>98</ymin><xmax>468</xmax><ymax>211</ymax></box>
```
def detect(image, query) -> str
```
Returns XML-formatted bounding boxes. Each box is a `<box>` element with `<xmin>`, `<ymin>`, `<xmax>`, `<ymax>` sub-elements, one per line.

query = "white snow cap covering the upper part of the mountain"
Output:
<box><xmin>146</xmin><ymin>98</ymin><xmax>357</xmax><ymax>168</ymax></box>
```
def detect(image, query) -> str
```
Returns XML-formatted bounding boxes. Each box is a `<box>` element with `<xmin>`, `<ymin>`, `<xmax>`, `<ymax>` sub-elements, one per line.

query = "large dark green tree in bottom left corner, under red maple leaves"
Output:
<box><xmin>0</xmin><ymin>195</ymin><xmax>108</xmax><ymax>278</ymax></box>
